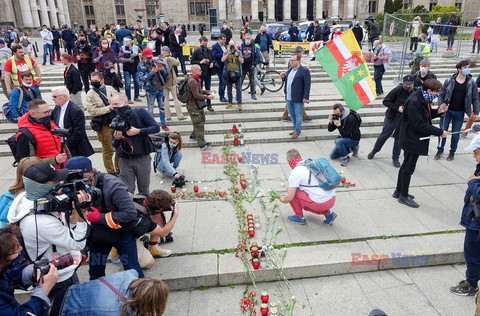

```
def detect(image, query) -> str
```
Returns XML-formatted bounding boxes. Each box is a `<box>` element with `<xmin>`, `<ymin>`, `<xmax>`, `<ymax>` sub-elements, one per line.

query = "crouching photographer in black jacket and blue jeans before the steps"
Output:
<box><xmin>328</xmin><ymin>103</ymin><xmax>362</xmax><ymax>166</ymax></box>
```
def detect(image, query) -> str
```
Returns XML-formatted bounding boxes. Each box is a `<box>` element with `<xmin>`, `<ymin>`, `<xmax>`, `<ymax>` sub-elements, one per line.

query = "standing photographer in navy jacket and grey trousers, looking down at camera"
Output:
<box><xmin>110</xmin><ymin>92</ymin><xmax>160</xmax><ymax>194</ymax></box>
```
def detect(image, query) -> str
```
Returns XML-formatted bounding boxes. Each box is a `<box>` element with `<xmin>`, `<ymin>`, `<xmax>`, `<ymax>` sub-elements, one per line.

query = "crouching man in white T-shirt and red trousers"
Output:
<box><xmin>280</xmin><ymin>149</ymin><xmax>337</xmax><ymax>225</ymax></box>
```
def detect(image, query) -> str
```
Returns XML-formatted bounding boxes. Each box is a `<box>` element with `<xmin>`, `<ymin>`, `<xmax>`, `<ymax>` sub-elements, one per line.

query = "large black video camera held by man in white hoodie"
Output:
<box><xmin>33</xmin><ymin>169</ymin><xmax>102</xmax><ymax>214</ymax></box>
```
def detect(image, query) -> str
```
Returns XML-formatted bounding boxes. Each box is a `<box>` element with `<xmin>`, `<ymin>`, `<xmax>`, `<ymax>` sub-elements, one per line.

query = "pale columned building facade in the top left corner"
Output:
<box><xmin>0</xmin><ymin>0</ymin><xmax>71</xmax><ymax>28</ymax></box>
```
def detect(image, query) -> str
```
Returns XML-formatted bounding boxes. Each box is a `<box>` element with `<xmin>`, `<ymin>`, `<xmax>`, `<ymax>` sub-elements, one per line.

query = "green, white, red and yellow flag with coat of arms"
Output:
<box><xmin>313</xmin><ymin>29</ymin><xmax>377</xmax><ymax>110</ymax></box>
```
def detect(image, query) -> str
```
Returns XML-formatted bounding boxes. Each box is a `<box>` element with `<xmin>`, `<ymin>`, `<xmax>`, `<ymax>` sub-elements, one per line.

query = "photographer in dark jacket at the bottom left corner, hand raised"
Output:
<box><xmin>0</xmin><ymin>225</ymin><xmax>58</xmax><ymax>316</ymax></box>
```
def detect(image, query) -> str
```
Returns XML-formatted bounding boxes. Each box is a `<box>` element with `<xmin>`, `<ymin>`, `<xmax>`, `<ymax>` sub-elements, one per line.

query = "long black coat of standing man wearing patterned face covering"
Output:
<box><xmin>399</xmin><ymin>89</ymin><xmax>443</xmax><ymax>156</ymax></box>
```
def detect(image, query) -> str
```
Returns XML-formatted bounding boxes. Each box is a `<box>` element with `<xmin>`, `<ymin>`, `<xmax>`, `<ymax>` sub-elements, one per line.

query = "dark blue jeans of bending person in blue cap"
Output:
<box><xmin>88</xmin><ymin>233</ymin><xmax>144</xmax><ymax>280</ymax></box>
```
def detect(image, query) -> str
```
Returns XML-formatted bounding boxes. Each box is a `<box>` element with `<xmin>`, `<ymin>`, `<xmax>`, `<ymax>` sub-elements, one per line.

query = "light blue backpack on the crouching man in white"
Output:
<box><xmin>297</xmin><ymin>158</ymin><xmax>342</xmax><ymax>191</ymax></box>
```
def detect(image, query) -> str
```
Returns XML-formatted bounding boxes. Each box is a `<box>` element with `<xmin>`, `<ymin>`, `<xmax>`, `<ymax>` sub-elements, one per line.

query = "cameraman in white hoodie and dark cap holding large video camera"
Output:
<box><xmin>8</xmin><ymin>163</ymin><xmax>91</xmax><ymax>314</ymax></box>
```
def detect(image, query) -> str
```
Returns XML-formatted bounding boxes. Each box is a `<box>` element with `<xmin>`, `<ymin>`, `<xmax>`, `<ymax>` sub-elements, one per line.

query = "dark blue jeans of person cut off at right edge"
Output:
<box><xmin>463</xmin><ymin>228</ymin><xmax>480</xmax><ymax>286</ymax></box>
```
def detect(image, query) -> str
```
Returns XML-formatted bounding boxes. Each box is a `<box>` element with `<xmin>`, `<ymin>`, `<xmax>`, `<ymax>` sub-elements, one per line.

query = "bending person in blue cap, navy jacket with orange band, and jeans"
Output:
<box><xmin>65</xmin><ymin>156</ymin><xmax>144</xmax><ymax>280</ymax></box>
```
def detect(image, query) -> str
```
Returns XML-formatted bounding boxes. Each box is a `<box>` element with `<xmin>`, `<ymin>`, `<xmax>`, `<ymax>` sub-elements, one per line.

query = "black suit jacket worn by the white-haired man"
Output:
<box><xmin>51</xmin><ymin>101</ymin><xmax>94</xmax><ymax>157</ymax></box>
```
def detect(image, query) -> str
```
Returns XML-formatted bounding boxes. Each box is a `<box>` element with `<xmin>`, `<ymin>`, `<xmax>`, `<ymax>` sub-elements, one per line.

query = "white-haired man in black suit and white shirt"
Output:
<box><xmin>51</xmin><ymin>87</ymin><xmax>94</xmax><ymax>157</ymax></box>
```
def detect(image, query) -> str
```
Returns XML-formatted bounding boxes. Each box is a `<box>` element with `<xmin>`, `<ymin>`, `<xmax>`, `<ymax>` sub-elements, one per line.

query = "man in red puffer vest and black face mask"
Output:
<box><xmin>17</xmin><ymin>99</ymin><xmax>70</xmax><ymax>168</ymax></box>
